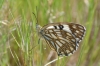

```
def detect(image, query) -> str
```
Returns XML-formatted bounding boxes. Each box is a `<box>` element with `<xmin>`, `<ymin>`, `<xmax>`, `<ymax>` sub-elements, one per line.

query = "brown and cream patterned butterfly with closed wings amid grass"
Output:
<box><xmin>36</xmin><ymin>22</ymin><xmax>86</xmax><ymax>56</ymax></box>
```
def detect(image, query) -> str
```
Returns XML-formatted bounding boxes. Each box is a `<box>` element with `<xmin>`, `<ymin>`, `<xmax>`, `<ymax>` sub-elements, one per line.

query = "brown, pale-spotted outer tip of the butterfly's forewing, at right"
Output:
<box><xmin>69</xmin><ymin>23</ymin><xmax>86</xmax><ymax>43</ymax></box>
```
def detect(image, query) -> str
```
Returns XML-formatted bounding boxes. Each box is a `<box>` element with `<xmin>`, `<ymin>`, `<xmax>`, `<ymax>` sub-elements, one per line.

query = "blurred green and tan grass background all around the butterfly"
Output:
<box><xmin>0</xmin><ymin>0</ymin><xmax>100</xmax><ymax>66</ymax></box>
